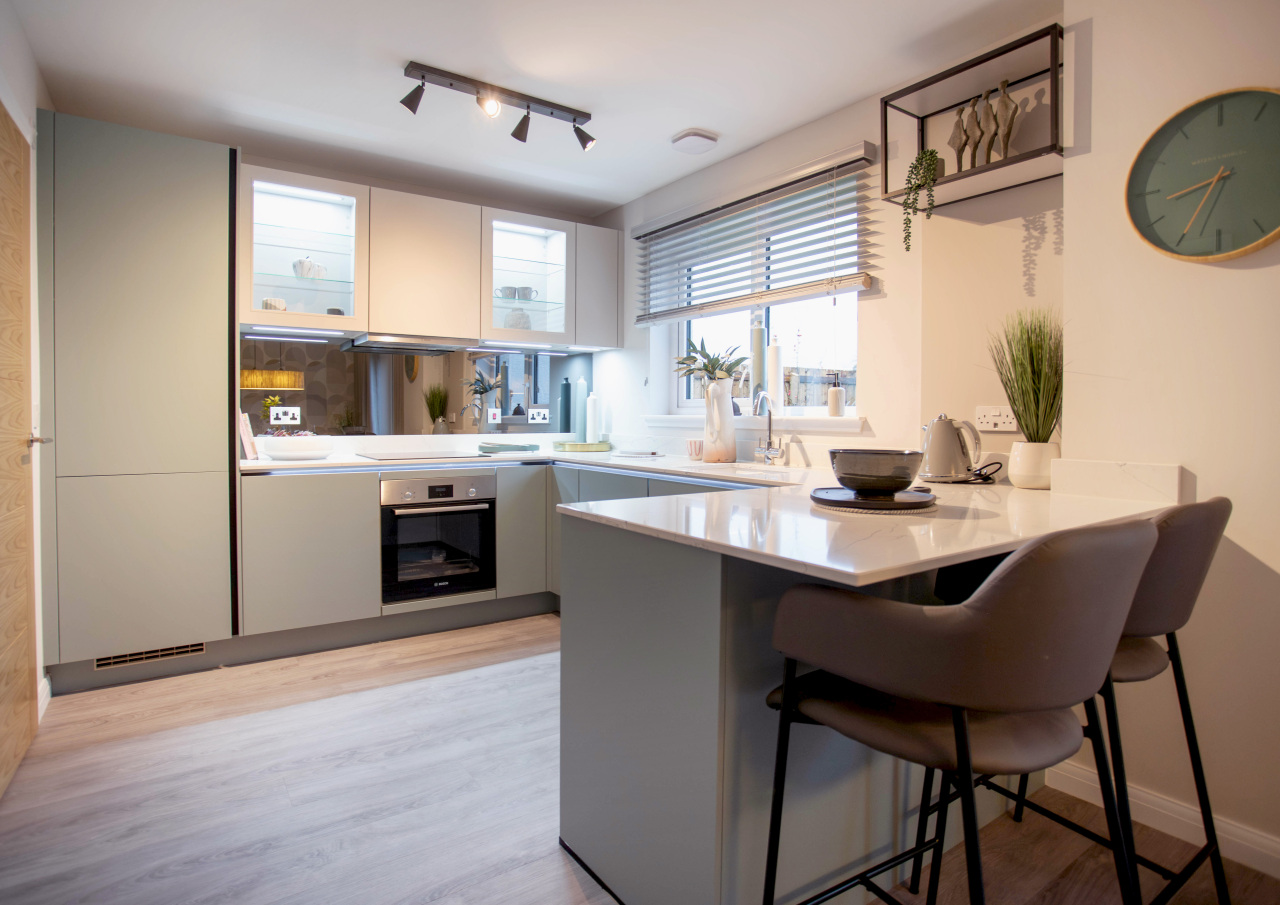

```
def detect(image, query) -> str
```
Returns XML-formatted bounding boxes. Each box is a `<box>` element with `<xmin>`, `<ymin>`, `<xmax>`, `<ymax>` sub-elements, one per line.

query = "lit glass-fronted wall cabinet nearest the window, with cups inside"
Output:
<box><xmin>480</xmin><ymin>207</ymin><xmax>577</xmax><ymax>344</ymax></box>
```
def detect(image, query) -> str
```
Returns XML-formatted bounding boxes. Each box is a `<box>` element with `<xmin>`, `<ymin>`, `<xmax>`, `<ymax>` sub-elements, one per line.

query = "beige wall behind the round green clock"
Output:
<box><xmin>1062</xmin><ymin>0</ymin><xmax>1280</xmax><ymax>858</ymax></box>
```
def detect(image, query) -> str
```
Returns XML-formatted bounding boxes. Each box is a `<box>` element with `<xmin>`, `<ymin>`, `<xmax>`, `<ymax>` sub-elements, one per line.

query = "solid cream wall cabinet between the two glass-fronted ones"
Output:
<box><xmin>369</xmin><ymin>188</ymin><xmax>481</xmax><ymax>340</ymax></box>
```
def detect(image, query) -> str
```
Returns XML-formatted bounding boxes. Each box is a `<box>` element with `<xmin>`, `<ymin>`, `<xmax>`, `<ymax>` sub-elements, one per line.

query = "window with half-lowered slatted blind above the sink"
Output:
<box><xmin>637</xmin><ymin>161</ymin><xmax>869</xmax><ymax>410</ymax></box>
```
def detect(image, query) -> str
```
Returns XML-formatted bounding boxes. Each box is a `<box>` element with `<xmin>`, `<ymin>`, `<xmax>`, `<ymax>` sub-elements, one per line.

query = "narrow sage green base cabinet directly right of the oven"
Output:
<box><xmin>497</xmin><ymin>465</ymin><xmax>547</xmax><ymax>598</ymax></box>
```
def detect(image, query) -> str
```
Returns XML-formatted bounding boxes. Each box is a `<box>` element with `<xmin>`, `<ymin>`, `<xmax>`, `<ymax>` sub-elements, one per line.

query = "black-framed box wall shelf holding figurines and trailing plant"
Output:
<box><xmin>881</xmin><ymin>23</ymin><xmax>1062</xmax><ymax>207</ymax></box>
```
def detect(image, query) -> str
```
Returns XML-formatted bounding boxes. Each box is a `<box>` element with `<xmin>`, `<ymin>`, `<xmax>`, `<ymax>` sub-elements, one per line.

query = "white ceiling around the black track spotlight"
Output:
<box><xmin>12</xmin><ymin>0</ymin><xmax>1061</xmax><ymax>216</ymax></box>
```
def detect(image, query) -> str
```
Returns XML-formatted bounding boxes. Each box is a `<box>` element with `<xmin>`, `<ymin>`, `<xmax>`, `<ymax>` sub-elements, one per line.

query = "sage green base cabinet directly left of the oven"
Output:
<box><xmin>241</xmin><ymin>471</ymin><xmax>383</xmax><ymax>635</ymax></box>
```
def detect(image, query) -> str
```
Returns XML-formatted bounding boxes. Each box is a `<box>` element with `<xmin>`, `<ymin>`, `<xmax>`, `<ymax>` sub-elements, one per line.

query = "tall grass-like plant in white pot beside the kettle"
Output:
<box><xmin>988</xmin><ymin>308</ymin><xmax>1062</xmax><ymax>490</ymax></box>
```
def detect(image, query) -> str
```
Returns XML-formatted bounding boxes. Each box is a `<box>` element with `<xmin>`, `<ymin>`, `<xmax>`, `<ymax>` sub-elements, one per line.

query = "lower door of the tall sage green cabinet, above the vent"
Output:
<box><xmin>50</xmin><ymin>472</ymin><xmax>232</xmax><ymax>663</ymax></box>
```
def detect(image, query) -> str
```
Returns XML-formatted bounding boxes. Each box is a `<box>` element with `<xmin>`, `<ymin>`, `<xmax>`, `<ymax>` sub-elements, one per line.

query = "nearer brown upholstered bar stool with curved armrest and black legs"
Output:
<box><xmin>764</xmin><ymin>521</ymin><xmax>1156</xmax><ymax>905</ymax></box>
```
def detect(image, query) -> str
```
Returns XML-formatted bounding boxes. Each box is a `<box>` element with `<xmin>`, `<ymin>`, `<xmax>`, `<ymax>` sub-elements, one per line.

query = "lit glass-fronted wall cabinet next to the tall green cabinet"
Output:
<box><xmin>237</xmin><ymin>165</ymin><xmax>369</xmax><ymax>333</ymax></box>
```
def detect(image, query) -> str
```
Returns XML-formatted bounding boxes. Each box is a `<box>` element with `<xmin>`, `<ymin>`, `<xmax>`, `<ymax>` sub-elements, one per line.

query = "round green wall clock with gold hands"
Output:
<box><xmin>1126</xmin><ymin>88</ymin><xmax>1280</xmax><ymax>262</ymax></box>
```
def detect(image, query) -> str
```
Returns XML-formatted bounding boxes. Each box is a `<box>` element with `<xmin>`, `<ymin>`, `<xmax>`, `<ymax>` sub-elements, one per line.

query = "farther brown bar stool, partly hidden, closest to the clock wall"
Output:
<box><xmin>983</xmin><ymin>497</ymin><xmax>1231</xmax><ymax>905</ymax></box>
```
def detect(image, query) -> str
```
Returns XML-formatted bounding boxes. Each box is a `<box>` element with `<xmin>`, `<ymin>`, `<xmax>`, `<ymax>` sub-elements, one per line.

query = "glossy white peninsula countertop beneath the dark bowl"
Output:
<box><xmin>557</xmin><ymin>481</ymin><xmax>1164</xmax><ymax>585</ymax></box>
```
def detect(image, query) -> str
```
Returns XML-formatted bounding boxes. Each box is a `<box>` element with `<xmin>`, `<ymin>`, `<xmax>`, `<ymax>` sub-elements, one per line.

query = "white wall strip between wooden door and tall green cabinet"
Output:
<box><xmin>0</xmin><ymin>0</ymin><xmax>52</xmax><ymax>716</ymax></box>
